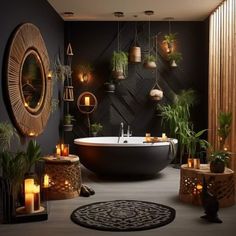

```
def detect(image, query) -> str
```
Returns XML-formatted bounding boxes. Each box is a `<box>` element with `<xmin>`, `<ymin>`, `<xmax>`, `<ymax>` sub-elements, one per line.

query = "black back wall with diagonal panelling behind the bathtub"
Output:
<box><xmin>65</xmin><ymin>21</ymin><xmax>208</xmax><ymax>144</ymax></box>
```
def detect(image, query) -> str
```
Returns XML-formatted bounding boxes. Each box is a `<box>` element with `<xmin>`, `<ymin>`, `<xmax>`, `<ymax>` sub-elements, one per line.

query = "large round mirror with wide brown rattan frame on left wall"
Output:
<box><xmin>7</xmin><ymin>23</ymin><xmax>52</xmax><ymax>136</ymax></box>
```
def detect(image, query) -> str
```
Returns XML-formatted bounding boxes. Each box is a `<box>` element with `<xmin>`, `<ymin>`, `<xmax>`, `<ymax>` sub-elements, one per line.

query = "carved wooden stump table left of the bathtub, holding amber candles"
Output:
<box><xmin>43</xmin><ymin>155</ymin><xmax>82</xmax><ymax>200</ymax></box>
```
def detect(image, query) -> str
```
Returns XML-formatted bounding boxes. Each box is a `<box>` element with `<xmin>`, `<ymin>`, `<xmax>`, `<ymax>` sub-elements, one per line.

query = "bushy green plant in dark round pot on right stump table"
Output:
<box><xmin>209</xmin><ymin>150</ymin><xmax>230</xmax><ymax>173</ymax></box>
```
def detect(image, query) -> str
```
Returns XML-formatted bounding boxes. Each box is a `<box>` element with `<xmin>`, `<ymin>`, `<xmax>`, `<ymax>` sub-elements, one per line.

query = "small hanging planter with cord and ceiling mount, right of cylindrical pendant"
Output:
<box><xmin>143</xmin><ymin>10</ymin><xmax>157</xmax><ymax>69</ymax></box>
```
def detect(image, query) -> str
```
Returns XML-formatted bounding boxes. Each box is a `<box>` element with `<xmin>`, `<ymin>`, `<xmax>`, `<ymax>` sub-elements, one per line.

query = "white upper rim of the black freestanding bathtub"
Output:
<box><xmin>74</xmin><ymin>136</ymin><xmax>178</xmax><ymax>147</ymax></box>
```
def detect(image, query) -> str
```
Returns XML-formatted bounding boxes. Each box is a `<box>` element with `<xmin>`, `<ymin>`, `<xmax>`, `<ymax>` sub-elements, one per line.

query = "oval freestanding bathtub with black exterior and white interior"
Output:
<box><xmin>74</xmin><ymin>137</ymin><xmax>178</xmax><ymax>176</ymax></box>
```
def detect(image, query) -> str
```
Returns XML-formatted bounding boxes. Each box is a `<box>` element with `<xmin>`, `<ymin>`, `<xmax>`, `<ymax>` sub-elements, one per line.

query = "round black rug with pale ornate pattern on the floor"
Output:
<box><xmin>71</xmin><ymin>200</ymin><xmax>175</xmax><ymax>231</ymax></box>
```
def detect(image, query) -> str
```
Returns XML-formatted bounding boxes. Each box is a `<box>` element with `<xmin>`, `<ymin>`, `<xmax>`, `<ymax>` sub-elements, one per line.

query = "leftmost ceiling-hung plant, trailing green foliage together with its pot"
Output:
<box><xmin>111</xmin><ymin>51</ymin><xmax>128</xmax><ymax>80</ymax></box>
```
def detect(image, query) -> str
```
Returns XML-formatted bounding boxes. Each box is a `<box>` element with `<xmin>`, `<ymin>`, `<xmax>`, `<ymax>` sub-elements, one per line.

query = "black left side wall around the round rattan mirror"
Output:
<box><xmin>0</xmin><ymin>0</ymin><xmax>64</xmax><ymax>153</ymax></box>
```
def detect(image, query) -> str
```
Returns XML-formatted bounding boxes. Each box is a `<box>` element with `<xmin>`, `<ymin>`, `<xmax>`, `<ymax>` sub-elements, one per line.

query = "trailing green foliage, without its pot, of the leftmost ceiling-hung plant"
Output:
<box><xmin>111</xmin><ymin>51</ymin><xmax>128</xmax><ymax>75</ymax></box>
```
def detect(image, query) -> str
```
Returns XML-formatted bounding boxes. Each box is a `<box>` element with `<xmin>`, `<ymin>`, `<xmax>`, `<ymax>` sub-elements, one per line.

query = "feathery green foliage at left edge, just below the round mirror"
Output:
<box><xmin>0</xmin><ymin>122</ymin><xmax>18</xmax><ymax>151</ymax></box>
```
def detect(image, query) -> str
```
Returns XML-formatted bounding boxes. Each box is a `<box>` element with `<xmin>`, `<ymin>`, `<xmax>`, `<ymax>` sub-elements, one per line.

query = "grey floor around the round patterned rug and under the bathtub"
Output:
<box><xmin>0</xmin><ymin>167</ymin><xmax>236</xmax><ymax>236</ymax></box>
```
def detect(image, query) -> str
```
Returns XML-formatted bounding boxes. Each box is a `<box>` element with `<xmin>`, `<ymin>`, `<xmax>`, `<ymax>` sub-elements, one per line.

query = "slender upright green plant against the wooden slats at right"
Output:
<box><xmin>218</xmin><ymin>112</ymin><xmax>232</xmax><ymax>149</ymax></box>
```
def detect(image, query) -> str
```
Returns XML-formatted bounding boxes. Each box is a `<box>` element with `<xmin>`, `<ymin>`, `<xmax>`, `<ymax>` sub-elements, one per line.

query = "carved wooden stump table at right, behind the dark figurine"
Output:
<box><xmin>179</xmin><ymin>164</ymin><xmax>235</xmax><ymax>207</ymax></box>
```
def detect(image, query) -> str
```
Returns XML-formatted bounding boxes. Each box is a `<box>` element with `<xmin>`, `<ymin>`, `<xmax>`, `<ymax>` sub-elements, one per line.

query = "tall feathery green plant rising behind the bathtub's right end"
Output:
<box><xmin>157</xmin><ymin>89</ymin><xmax>197</xmax><ymax>163</ymax></box>
